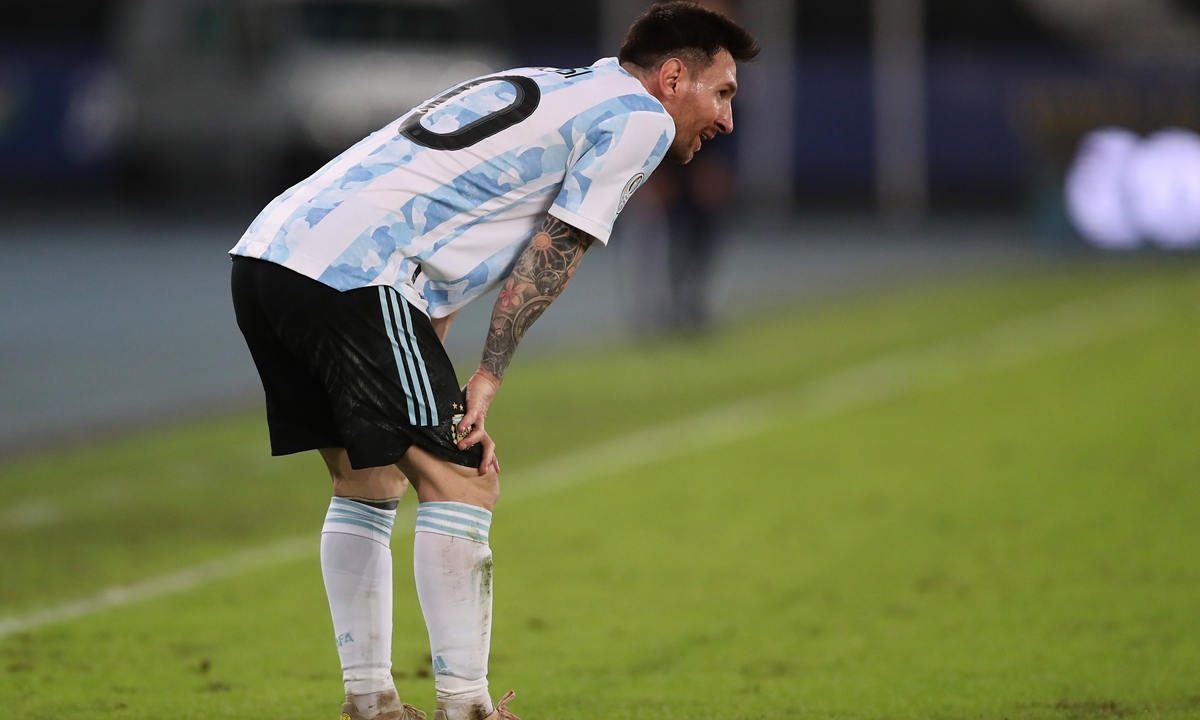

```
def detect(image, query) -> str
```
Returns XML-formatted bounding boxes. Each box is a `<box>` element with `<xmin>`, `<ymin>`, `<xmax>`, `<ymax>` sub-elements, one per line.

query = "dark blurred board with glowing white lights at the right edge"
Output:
<box><xmin>1015</xmin><ymin>74</ymin><xmax>1200</xmax><ymax>250</ymax></box>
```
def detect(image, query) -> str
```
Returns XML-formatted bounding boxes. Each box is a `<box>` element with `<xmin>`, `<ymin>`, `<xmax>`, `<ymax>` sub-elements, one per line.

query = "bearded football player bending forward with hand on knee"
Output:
<box><xmin>230</xmin><ymin>2</ymin><xmax>758</xmax><ymax>720</ymax></box>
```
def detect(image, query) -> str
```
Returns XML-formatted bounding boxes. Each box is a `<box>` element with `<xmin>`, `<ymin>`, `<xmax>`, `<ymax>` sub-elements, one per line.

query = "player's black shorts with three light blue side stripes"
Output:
<box><xmin>233</xmin><ymin>257</ymin><xmax>484</xmax><ymax>469</ymax></box>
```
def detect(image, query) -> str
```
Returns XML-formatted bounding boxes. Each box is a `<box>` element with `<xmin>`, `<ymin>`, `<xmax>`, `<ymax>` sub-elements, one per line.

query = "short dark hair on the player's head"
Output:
<box><xmin>617</xmin><ymin>0</ymin><xmax>761</xmax><ymax>70</ymax></box>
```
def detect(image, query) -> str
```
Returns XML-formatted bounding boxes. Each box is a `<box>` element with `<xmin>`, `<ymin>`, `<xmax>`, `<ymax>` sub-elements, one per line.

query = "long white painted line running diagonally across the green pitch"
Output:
<box><xmin>0</xmin><ymin>288</ymin><xmax>1162</xmax><ymax>637</ymax></box>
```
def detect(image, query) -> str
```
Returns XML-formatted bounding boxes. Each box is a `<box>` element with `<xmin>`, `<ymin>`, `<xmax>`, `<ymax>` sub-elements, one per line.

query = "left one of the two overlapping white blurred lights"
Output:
<box><xmin>1066</xmin><ymin>127</ymin><xmax>1141</xmax><ymax>250</ymax></box>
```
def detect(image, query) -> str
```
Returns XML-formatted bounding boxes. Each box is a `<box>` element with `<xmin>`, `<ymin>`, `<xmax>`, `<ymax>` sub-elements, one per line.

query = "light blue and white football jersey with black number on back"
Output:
<box><xmin>230</xmin><ymin>58</ymin><xmax>674</xmax><ymax>317</ymax></box>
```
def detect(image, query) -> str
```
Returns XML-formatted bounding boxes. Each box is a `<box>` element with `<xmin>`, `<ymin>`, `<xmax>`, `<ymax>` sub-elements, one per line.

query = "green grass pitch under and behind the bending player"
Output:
<box><xmin>0</xmin><ymin>263</ymin><xmax>1200</xmax><ymax>720</ymax></box>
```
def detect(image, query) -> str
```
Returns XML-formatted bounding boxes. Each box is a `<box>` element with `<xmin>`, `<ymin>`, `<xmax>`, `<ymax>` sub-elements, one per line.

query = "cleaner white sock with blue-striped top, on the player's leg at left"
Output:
<box><xmin>320</xmin><ymin>498</ymin><xmax>396</xmax><ymax>696</ymax></box>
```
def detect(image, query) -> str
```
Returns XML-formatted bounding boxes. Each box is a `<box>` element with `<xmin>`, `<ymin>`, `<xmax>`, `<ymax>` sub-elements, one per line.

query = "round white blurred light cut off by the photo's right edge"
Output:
<box><xmin>1126</xmin><ymin>128</ymin><xmax>1200</xmax><ymax>248</ymax></box>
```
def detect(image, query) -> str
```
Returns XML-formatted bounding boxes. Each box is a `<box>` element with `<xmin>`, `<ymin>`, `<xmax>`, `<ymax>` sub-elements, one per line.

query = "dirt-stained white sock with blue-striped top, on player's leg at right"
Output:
<box><xmin>413</xmin><ymin>503</ymin><xmax>494</xmax><ymax>720</ymax></box>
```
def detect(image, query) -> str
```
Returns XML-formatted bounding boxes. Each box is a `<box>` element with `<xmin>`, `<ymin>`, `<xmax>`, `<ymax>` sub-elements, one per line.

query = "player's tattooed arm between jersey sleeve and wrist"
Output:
<box><xmin>480</xmin><ymin>216</ymin><xmax>592</xmax><ymax>378</ymax></box>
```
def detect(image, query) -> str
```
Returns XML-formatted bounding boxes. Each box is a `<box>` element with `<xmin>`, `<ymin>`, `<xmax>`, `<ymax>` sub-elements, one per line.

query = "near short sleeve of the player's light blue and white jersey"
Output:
<box><xmin>550</xmin><ymin>112</ymin><xmax>674</xmax><ymax>245</ymax></box>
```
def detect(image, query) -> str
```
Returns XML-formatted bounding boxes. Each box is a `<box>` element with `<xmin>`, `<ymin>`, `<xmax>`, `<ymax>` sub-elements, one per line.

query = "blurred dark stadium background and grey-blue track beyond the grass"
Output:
<box><xmin>9</xmin><ymin>0</ymin><xmax>1200</xmax><ymax>448</ymax></box>
